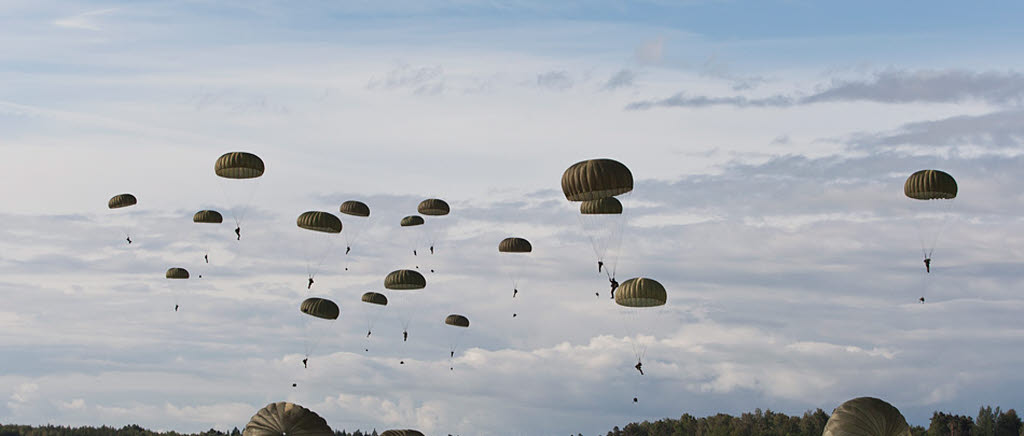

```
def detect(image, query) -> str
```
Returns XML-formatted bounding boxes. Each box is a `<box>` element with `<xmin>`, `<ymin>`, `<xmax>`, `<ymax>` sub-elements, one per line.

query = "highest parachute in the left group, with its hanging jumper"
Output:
<box><xmin>213</xmin><ymin>151</ymin><xmax>266</xmax><ymax>241</ymax></box>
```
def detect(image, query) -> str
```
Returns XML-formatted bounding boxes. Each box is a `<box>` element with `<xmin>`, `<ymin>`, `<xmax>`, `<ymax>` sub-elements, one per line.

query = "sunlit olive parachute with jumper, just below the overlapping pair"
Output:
<box><xmin>615</xmin><ymin>277</ymin><xmax>669</xmax><ymax>375</ymax></box>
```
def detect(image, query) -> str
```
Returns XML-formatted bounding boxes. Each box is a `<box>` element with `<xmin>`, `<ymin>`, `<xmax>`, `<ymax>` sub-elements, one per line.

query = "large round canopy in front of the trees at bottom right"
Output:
<box><xmin>821</xmin><ymin>397</ymin><xmax>910</xmax><ymax>436</ymax></box>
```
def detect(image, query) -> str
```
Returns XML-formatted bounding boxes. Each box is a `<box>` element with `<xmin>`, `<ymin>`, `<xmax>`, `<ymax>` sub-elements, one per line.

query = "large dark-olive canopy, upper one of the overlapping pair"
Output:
<box><xmin>562</xmin><ymin>159</ymin><xmax>633</xmax><ymax>202</ymax></box>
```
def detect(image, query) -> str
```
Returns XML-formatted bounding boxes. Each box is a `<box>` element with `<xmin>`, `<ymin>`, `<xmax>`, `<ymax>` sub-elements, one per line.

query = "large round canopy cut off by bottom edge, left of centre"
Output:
<box><xmin>242</xmin><ymin>401</ymin><xmax>334</xmax><ymax>436</ymax></box>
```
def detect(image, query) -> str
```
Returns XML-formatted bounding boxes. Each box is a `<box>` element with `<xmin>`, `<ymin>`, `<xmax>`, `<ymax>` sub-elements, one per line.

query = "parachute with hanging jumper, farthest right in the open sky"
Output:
<box><xmin>903</xmin><ymin>170</ymin><xmax>957</xmax><ymax>272</ymax></box>
